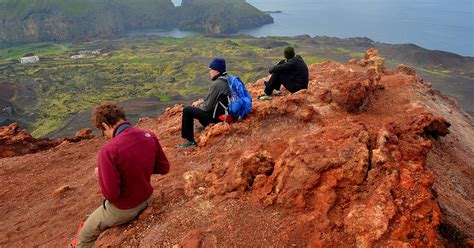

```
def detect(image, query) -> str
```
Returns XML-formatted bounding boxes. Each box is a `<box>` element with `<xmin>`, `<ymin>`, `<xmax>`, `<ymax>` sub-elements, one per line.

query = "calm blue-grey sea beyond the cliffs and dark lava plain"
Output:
<box><xmin>162</xmin><ymin>0</ymin><xmax>474</xmax><ymax>56</ymax></box>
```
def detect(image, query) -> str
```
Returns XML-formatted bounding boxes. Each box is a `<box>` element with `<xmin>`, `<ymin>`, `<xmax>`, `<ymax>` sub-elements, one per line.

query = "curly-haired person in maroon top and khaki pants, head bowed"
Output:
<box><xmin>77</xmin><ymin>103</ymin><xmax>169</xmax><ymax>247</ymax></box>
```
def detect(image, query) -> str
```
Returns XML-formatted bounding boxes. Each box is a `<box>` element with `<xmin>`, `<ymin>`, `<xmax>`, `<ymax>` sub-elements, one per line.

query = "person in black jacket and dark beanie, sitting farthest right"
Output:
<box><xmin>258</xmin><ymin>47</ymin><xmax>309</xmax><ymax>100</ymax></box>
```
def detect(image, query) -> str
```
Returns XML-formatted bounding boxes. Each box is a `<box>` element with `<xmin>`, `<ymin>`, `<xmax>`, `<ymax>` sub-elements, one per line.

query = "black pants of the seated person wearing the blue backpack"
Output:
<box><xmin>181</xmin><ymin>107</ymin><xmax>221</xmax><ymax>141</ymax></box>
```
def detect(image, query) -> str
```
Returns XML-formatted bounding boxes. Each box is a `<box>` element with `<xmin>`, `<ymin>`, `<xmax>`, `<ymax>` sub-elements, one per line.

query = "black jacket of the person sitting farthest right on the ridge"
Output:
<box><xmin>269</xmin><ymin>55</ymin><xmax>309</xmax><ymax>89</ymax></box>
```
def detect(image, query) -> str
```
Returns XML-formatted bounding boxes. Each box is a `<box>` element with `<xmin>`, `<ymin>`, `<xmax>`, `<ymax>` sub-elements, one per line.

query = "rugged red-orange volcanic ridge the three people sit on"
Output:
<box><xmin>0</xmin><ymin>50</ymin><xmax>474</xmax><ymax>247</ymax></box>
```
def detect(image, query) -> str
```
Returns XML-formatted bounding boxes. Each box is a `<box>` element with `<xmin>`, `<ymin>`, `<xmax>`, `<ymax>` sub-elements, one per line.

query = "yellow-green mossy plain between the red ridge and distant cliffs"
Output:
<box><xmin>0</xmin><ymin>36</ymin><xmax>472</xmax><ymax>137</ymax></box>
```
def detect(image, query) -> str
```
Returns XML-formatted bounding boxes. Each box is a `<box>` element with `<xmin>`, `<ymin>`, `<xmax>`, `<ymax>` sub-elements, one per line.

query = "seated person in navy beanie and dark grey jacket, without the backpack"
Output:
<box><xmin>178</xmin><ymin>58</ymin><xmax>230</xmax><ymax>148</ymax></box>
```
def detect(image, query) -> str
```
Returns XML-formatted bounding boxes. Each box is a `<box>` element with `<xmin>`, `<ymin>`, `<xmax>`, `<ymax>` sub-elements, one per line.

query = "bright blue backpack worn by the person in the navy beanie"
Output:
<box><xmin>227</xmin><ymin>75</ymin><xmax>252</xmax><ymax>120</ymax></box>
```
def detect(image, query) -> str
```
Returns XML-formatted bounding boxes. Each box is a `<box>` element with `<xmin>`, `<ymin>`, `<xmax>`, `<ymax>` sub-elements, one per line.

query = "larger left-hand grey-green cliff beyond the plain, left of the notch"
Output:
<box><xmin>0</xmin><ymin>0</ymin><xmax>174</xmax><ymax>43</ymax></box>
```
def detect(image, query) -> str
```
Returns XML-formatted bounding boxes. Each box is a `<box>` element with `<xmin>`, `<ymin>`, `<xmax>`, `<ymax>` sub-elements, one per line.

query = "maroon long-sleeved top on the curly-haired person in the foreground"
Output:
<box><xmin>99</xmin><ymin>122</ymin><xmax>170</xmax><ymax>209</ymax></box>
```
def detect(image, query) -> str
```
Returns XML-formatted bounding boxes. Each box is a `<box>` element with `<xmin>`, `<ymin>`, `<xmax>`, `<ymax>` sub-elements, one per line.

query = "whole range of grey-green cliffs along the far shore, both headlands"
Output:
<box><xmin>0</xmin><ymin>0</ymin><xmax>273</xmax><ymax>43</ymax></box>
